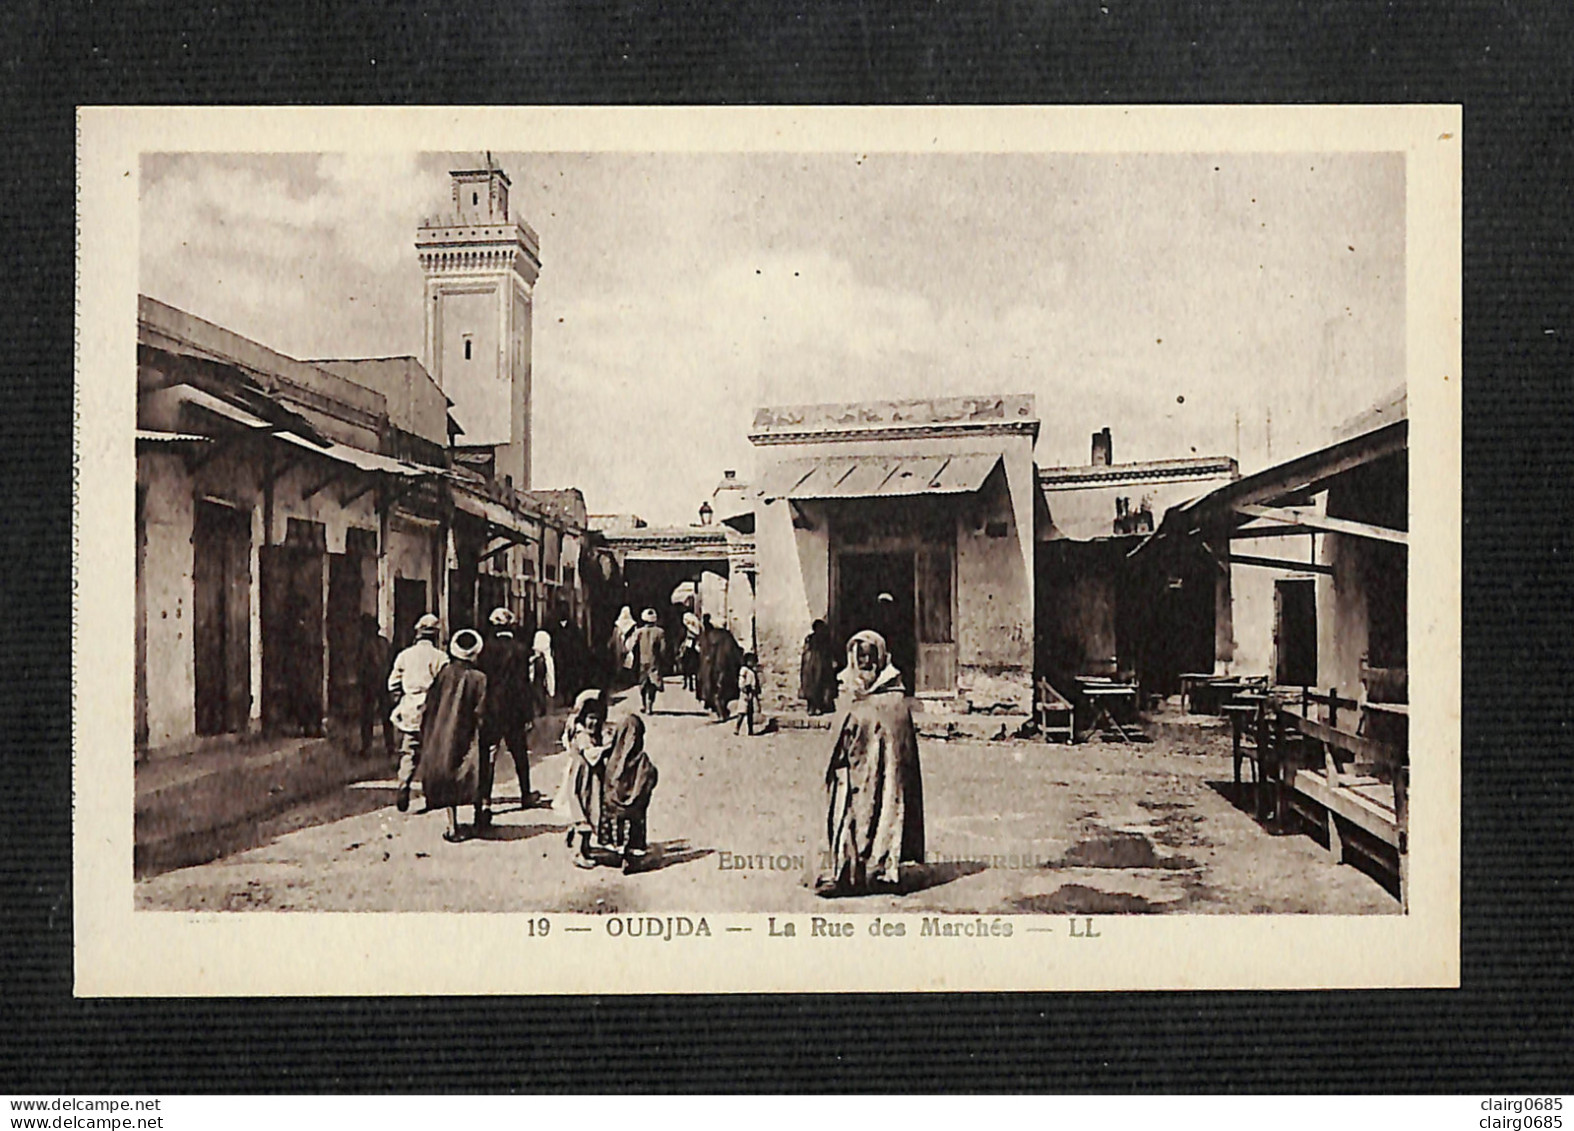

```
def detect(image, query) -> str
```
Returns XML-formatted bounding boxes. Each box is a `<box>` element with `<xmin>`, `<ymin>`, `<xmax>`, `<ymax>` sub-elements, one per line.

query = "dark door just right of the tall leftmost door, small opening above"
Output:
<box><xmin>260</xmin><ymin>519</ymin><xmax>324</xmax><ymax>735</ymax></box>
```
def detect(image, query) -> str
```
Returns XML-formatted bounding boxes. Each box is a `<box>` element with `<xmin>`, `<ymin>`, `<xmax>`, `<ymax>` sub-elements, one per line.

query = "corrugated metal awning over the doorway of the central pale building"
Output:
<box><xmin>760</xmin><ymin>451</ymin><xmax>999</xmax><ymax>499</ymax></box>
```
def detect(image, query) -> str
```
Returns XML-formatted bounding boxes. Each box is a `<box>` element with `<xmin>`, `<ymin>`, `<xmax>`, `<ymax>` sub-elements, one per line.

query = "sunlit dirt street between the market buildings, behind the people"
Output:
<box><xmin>137</xmin><ymin>684</ymin><xmax>1399</xmax><ymax>914</ymax></box>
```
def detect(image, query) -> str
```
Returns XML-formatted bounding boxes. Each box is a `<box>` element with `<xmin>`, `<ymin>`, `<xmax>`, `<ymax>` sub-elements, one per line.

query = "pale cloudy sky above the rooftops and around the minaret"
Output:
<box><xmin>140</xmin><ymin>151</ymin><xmax>1404</xmax><ymax>522</ymax></box>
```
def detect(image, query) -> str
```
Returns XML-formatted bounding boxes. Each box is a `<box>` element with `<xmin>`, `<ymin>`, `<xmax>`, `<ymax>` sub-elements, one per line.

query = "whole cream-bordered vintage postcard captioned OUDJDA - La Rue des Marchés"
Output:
<box><xmin>74</xmin><ymin>107</ymin><xmax>1461</xmax><ymax>996</ymax></box>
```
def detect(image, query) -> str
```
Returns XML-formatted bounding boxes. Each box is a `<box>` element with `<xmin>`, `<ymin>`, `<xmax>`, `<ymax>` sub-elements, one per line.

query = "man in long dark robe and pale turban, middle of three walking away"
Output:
<box><xmin>420</xmin><ymin>628</ymin><xmax>486</xmax><ymax>843</ymax></box>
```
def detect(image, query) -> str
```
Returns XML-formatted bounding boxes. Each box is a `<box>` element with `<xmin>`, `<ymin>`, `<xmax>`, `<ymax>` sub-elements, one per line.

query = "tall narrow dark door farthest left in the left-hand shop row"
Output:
<box><xmin>192</xmin><ymin>500</ymin><xmax>252</xmax><ymax>735</ymax></box>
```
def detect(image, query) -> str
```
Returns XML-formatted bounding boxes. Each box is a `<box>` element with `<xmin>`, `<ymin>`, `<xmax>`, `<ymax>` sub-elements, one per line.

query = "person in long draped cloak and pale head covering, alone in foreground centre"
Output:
<box><xmin>814</xmin><ymin>631</ymin><xmax>924</xmax><ymax>897</ymax></box>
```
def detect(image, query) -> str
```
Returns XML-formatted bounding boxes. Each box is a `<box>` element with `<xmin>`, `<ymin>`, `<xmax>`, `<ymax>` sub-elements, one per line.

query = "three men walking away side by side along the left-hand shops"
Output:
<box><xmin>387</xmin><ymin>609</ymin><xmax>557</xmax><ymax>842</ymax></box>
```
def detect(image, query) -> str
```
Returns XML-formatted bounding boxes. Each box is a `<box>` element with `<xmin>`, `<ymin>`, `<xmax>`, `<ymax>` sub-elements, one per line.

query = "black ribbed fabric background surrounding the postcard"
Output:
<box><xmin>0</xmin><ymin>0</ymin><xmax>1574</xmax><ymax>1093</ymax></box>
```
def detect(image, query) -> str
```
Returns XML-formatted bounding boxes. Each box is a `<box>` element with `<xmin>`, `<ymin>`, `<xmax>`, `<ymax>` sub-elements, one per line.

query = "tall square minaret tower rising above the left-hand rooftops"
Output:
<box><xmin>416</xmin><ymin>153</ymin><xmax>541</xmax><ymax>489</ymax></box>
